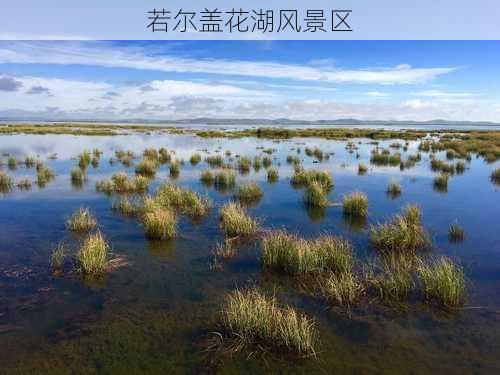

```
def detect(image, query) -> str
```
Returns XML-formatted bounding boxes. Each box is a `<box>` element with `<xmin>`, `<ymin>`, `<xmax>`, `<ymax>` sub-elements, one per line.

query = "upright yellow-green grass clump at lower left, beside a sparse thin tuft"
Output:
<box><xmin>76</xmin><ymin>232</ymin><xmax>109</xmax><ymax>275</ymax></box>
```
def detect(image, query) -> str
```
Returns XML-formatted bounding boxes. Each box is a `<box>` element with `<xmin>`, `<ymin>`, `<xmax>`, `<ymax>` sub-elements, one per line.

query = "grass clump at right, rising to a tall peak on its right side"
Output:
<box><xmin>370</xmin><ymin>205</ymin><xmax>430</xmax><ymax>253</ymax></box>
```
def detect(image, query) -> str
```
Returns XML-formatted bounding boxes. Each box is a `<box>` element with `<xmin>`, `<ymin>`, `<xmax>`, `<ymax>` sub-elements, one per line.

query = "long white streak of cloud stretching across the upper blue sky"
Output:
<box><xmin>0</xmin><ymin>42</ymin><xmax>455</xmax><ymax>85</ymax></box>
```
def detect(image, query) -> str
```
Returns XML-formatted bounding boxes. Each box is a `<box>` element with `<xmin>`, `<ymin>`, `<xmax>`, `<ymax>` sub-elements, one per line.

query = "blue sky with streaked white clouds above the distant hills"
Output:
<box><xmin>0</xmin><ymin>40</ymin><xmax>500</xmax><ymax>122</ymax></box>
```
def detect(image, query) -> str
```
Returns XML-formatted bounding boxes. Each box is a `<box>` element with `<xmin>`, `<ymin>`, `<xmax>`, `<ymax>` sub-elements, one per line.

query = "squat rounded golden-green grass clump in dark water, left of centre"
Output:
<box><xmin>142</xmin><ymin>207</ymin><xmax>177</xmax><ymax>240</ymax></box>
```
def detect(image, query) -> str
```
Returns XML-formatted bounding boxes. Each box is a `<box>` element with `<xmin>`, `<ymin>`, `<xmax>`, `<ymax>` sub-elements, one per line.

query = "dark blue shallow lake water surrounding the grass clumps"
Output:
<box><xmin>0</xmin><ymin>134</ymin><xmax>500</xmax><ymax>374</ymax></box>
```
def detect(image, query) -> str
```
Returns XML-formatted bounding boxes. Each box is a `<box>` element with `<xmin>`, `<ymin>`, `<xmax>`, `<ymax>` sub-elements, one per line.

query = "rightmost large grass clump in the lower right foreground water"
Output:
<box><xmin>418</xmin><ymin>258</ymin><xmax>466</xmax><ymax>308</ymax></box>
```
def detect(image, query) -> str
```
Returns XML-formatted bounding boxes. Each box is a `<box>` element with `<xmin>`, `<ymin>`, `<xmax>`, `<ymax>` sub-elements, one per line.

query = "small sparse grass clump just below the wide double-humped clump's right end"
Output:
<box><xmin>320</xmin><ymin>272</ymin><xmax>363</xmax><ymax>307</ymax></box>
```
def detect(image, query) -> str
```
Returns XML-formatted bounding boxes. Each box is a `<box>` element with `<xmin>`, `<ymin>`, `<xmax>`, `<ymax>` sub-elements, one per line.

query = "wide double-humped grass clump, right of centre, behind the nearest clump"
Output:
<box><xmin>261</xmin><ymin>230</ymin><xmax>354</xmax><ymax>275</ymax></box>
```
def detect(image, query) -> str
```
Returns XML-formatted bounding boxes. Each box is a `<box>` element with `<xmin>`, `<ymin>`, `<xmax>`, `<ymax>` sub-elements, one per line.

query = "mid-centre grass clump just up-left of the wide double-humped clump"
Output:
<box><xmin>220</xmin><ymin>202</ymin><xmax>259</xmax><ymax>237</ymax></box>
